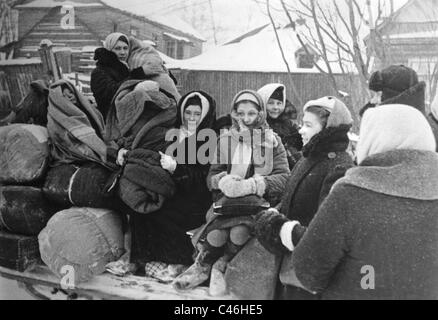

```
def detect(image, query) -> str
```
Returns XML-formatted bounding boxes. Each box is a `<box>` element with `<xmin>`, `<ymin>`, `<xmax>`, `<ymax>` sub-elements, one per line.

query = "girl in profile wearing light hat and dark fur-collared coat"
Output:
<box><xmin>255</xmin><ymin>97</ymin><xmax>353</xmax><ymax>299</ymax></box>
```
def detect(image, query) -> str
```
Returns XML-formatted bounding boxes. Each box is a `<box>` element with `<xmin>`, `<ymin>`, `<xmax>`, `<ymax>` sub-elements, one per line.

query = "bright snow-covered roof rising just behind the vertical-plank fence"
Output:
<box><xmin>168</xmin><ymin>26</ymin><xmax>352</xmax><ymax>73</ymax></box>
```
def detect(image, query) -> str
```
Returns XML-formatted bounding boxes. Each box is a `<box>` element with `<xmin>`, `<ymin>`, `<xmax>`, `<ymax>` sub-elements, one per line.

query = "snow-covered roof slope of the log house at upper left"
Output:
<box><xmin>101</xmin><ymin>0</ymin><xmax>206</xmax><ymax>41</ymax></box>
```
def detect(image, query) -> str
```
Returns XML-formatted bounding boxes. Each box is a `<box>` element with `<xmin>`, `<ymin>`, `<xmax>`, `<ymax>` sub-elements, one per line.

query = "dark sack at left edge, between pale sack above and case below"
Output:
<box><xmin>0</xmin><ymin>186</ymin><xmax>57</xmax><ymax>236</ymax></box>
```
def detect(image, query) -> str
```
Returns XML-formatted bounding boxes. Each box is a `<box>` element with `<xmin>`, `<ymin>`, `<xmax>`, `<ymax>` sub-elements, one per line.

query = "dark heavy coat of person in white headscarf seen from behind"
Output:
<box><xmin>293</xmin><ymin>149</ymin><xmax>438</xmax><ymax>300</ymax></box>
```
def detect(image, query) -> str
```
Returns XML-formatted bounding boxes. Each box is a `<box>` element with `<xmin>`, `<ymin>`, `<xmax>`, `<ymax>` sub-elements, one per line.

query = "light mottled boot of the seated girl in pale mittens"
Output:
<box><xmin>172</xmin><ymin>242</ymin><xmax>223</xmax><ymax>291</ymax></box>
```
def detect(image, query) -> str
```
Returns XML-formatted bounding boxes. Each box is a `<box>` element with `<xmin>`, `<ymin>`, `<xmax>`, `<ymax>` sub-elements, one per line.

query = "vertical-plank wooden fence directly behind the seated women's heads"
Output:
<box><xmin>171</xmin><ymin>69</ymin><xmax>366</xmax><ymax>131</ymax></box>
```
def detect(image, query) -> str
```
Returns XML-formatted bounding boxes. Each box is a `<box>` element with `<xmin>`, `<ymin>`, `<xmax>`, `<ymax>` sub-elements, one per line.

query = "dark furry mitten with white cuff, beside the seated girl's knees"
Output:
<box><xmin>253</xmin><ymin>208</ymin><xmax>289</xmax><ymax>254</ymax></box>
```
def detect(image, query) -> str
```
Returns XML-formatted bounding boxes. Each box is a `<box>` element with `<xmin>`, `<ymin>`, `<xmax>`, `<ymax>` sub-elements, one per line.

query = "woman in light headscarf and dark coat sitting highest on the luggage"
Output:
<box><xmin>90</xmin><ymin>32</ymin><xmax>145</xmax><ymax>119</ymax></box>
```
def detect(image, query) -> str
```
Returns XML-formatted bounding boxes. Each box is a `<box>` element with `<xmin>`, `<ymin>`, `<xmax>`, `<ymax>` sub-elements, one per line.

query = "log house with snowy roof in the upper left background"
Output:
<box><xmin>14</xmin><ymin>0</ymin><xmax>205</xmax><ymax>59</ymax></box>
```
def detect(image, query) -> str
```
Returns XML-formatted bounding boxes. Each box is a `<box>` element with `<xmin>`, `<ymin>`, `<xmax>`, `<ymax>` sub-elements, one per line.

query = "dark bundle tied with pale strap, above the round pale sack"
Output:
<box><xmin>43</xmin><ymin>163</ymin><xmax>117</xmax><ymax>209</ymax></box>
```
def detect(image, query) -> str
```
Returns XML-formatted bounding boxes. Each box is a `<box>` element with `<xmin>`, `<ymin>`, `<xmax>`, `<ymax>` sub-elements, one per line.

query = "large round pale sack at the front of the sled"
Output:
<box><xmin>38</xmin><ymin>207</ymin><xmax>124</xmax><ymax>285</ymax></box>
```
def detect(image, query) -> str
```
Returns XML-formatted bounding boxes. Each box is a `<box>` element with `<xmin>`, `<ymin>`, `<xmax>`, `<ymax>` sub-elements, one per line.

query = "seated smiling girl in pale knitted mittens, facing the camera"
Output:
<box><xmin>173</xmin><ymin>90</ymin><xmax>289</xmax><ymax>290</ymax></box>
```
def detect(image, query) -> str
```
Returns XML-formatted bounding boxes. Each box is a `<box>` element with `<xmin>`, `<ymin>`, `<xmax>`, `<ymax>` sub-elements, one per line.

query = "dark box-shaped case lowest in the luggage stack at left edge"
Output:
<box><xmin>0</xmin><ymin>230</ymin><xmax>40</xmax><ymax>272</ymax></box>
